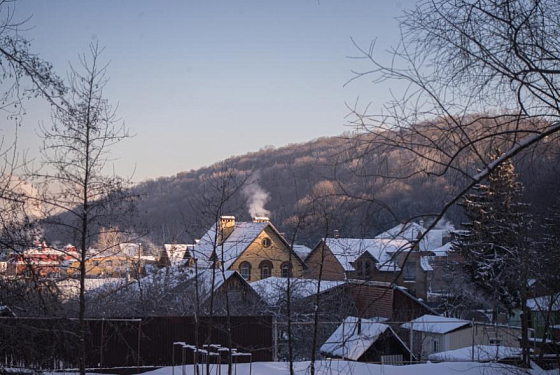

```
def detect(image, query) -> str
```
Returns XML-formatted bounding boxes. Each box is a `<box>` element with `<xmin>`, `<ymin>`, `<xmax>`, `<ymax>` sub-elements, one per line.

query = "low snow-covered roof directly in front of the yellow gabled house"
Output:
<box><xmin>249</xmin><ymin>277</ymin><xmax>344</xmax><ymax>306</ymax></box>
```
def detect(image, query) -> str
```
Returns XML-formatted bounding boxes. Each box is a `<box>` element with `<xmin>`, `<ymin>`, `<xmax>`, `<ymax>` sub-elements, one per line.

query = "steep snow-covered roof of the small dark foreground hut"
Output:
<box><xmin>321</xmin><ymin>316</ymin><xmax>406</xmax><ymax>361</ymax></box>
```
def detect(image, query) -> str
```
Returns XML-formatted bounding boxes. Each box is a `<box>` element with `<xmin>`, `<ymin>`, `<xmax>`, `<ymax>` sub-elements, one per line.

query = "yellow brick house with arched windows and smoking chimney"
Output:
<box><xmin>193</xmin><ymin>216</ymin><xmax>307</xmax><ymax>282</ymax></box>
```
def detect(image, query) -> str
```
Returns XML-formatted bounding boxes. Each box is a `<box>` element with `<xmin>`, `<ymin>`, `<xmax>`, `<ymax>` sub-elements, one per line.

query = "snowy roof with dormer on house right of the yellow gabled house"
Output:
<box><xmin>323</xmin><ymin>238</ymin><xmax>404</xmax><ymax>271</ymax></box>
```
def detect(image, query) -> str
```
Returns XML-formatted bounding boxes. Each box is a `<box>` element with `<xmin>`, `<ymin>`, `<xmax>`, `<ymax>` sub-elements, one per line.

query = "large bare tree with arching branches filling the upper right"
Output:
<box><xmin>351</xmin><ymin>0</ymin><xmax>560</xmax><ymax>228</ymax></box>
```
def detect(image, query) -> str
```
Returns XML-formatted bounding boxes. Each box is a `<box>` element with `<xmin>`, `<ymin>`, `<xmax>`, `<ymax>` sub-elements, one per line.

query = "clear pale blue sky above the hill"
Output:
<box><xmin>8</xmin><ymin>0</ymin><xmax>415</xmax><ymax>181</ymax></box>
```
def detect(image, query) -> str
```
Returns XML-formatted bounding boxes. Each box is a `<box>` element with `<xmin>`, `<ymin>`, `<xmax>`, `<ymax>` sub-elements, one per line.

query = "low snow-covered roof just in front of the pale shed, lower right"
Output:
<box><xmin>428</xmin><ymin>345</ymin><xmax>523</xmax><ymax>362</ymax></box>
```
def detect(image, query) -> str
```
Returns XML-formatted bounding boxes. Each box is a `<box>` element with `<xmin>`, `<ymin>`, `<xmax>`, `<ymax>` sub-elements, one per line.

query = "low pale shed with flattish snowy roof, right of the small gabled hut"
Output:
<box><xmin>399</xmin><ymin>315</ymin><xmax>521</xmax><ymax>359</ymax></box>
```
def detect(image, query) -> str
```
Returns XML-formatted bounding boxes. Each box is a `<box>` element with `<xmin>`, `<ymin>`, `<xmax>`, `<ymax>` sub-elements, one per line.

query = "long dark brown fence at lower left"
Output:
<box><xmin>0</xmin><ymin>316</ymin><xmax>273</xmax><ymax>370</ymax></box>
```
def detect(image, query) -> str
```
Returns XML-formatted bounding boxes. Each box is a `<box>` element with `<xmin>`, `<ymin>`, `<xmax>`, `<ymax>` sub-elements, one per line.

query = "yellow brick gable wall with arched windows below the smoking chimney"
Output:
<box><xmin>230</xmin><ymin>227</ymin><xmax>303</xmax><ymax>282</ymax></box>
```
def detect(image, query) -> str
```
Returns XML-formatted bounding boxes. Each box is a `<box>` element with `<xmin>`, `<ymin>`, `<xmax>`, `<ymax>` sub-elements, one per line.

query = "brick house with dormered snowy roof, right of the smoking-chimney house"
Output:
<box><xmin>305</xmin><ymin>223</ymin><xmax>450</xmax><ymax>300</ymax></box>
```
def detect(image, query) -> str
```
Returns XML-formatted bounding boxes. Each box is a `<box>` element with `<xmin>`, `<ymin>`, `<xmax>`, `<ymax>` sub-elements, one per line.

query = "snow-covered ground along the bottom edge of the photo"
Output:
<box><xmin>138</xmin><ymin>361</ymin><xmax>549</xmax><ymax>375</ymax></box>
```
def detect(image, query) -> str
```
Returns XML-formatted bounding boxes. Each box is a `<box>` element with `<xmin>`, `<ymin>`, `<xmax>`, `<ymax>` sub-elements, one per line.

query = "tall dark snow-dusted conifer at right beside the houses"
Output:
<box><xmin>453</xmin><ymin>150</ymin><xmax>532</xmax><ymax>312</ymax></box>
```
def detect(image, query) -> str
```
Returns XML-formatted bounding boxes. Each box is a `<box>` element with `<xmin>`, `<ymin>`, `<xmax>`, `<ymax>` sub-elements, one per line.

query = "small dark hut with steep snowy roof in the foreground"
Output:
<box><xmin>321</xmin><ymin>316</ymin><xmax>412</xmax><ymax>365</ymax></box>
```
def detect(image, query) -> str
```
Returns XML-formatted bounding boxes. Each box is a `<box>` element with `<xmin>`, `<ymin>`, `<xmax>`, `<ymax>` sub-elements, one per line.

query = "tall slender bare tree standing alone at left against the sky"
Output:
<box><xmin>29</xmin><ymin>44</ymin><xmax>132</xmax><ymax>374</ymax></box>
